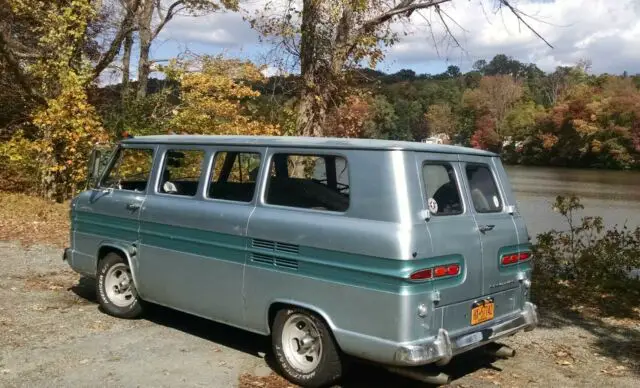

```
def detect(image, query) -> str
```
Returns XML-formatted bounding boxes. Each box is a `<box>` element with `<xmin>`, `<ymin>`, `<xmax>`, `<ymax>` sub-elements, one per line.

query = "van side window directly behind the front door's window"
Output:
<box><xmin>158</xmin><ymin>150</ymin><xmax>204</xmax><ymax>197</ymax></box>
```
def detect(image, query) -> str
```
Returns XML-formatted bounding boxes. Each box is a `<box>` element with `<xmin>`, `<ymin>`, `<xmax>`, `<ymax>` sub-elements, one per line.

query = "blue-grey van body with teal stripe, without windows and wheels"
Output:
<box><xmin>65</xmin><ymin>136</ymin><xmax>537</xmax><ymax>365</ymax></box>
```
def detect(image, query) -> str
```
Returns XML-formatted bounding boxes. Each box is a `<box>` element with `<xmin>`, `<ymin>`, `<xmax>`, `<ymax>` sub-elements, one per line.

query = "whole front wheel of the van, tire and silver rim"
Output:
<box><xmin>96</xmin><ymin>253</ymin><xmax>142</xmax><ymax>318</ymax></box>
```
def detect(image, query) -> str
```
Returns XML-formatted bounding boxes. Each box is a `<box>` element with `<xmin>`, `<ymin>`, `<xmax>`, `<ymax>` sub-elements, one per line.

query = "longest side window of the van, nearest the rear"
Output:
<box><xmin>266</xmin><ymin>154</ymin><xmax>349</xmax><ymax>212</ymax></box>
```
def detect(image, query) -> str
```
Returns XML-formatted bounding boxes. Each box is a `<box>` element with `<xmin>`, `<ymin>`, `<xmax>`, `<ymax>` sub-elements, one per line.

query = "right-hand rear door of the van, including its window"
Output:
<box><xmin>460</xmin><ymin>155</ymin><xmax>522</xmax><ymax>298</ymax></box>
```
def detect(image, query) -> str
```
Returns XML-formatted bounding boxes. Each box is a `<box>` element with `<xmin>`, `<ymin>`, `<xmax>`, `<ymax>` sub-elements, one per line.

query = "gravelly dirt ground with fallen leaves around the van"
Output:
<box><xmin>0</xmin><ymin>242</ymin><xmax>640</xmax><ymax>388</ymax></box>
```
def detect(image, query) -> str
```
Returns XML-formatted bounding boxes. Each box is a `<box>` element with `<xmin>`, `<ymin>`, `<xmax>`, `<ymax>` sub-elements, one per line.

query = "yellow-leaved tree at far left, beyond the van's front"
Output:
<box><xmin>0</xmin><ymin>0</ymin><xmax>106</xmax><ymax>201</ymax></box>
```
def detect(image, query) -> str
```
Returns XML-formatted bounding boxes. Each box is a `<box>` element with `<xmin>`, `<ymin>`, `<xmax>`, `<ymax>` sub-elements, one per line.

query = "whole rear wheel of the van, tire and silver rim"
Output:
<box><xmin>272</xmin><ymin>308</ymin><xmax>342</xmax><ymax>387</ymax></box>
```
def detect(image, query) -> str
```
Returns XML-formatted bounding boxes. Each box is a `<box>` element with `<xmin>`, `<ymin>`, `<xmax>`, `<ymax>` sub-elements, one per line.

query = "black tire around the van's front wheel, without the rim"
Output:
<box><xmin>96</xmin><ymin>253</ymin><xmax>143</xmax><ymax>319</ymax></box>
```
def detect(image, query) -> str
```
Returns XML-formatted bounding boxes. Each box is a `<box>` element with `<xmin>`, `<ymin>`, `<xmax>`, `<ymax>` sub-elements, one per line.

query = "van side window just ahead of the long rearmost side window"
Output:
<box><xmin>209</xmin><ymin>152</ymin><xmax>260</xmax><ymax>202</ymax></box>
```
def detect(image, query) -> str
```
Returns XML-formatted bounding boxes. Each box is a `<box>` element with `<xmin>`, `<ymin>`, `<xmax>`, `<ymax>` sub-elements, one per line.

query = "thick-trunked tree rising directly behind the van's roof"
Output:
<box><xmin>252</xmin><ymin>0</ymin><xmax>552</xmax><ymax>136</ymax></box>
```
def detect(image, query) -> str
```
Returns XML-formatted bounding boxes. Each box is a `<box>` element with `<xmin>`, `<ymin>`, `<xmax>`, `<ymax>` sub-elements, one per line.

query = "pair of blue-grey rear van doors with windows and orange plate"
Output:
<box><xmin>417</xmin><ymin>154</ymin><xmax>528</xmax><ymax>330</ymax></box>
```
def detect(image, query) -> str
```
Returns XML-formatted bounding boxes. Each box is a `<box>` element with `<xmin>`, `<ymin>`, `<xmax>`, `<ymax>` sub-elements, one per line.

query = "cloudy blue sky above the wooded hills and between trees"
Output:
<box><xmin>100</xmin><ymin>0</ymin><xmax>640</xmax><ymax>83</ymax></box>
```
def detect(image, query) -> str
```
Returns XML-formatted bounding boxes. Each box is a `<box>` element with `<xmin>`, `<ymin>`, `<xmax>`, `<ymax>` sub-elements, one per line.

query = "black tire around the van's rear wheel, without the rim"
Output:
<box><xmin>271</xmin><ymin>307</ymin><xmax>344</xmax><ymax>388</ymax></box>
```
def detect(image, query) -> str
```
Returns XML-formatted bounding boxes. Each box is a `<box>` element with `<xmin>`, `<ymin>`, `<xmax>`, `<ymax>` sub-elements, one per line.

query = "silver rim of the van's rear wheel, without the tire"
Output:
<box><xmin>282</xmin><ymin>314</ymin><xmax>322</xmax><ymax>373</ymax></box>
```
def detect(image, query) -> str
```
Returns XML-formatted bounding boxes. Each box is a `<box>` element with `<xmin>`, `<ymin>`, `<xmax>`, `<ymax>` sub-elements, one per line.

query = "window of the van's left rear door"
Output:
<box><xmin>422</xmin><ymin>163</ymin><xmax>462</xmax><ymax>216</ymax></box>
